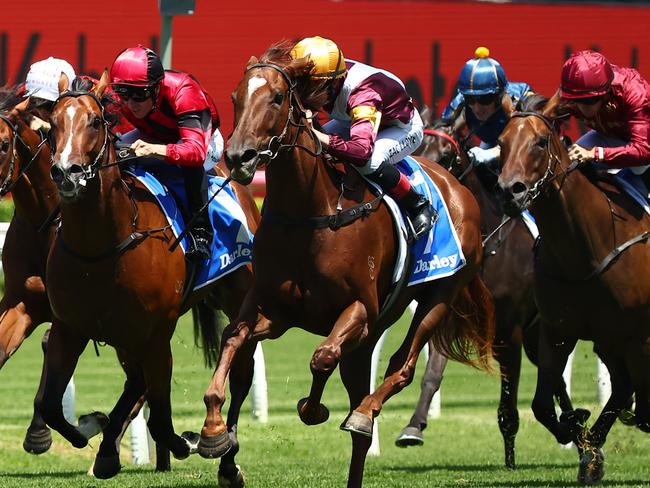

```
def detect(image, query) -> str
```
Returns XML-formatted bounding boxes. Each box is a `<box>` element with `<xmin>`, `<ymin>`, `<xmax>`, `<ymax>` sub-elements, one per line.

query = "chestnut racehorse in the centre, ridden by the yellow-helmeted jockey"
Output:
<box><xmin>199</xmin><ymin>43</ymin><xmax>493</xmax><ymax>487</ymax></box>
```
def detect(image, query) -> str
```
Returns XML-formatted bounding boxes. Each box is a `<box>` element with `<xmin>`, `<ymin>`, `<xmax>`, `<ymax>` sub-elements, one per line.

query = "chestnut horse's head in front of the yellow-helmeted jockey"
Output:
<box><xmin>224</xmin><ymin>43</ymin><xmax>313</xmax><ymax>184</ymax></box>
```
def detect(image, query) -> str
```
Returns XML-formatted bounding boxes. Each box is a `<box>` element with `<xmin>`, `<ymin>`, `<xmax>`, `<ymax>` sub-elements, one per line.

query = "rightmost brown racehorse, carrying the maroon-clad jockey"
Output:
<box><xmin>499</xmin><ymin>95</ymin><xmax>650</xmax><ymax>484</ymax></box>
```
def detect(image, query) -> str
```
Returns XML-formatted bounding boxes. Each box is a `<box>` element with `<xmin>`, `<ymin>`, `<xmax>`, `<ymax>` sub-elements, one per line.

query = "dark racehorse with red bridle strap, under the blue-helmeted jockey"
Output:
<box><xmin>395</xmin><ymin>109</ymin><xmax>573</xmax><ymax>468</ymax></box>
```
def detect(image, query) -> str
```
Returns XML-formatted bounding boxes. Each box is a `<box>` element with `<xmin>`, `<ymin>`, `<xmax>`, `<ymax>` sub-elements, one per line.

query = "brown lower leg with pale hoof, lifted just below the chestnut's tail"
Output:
<box><xmin>395</xmin><ymin>341</ymin><xmax>447</xmax><ymax>447</ymax></box>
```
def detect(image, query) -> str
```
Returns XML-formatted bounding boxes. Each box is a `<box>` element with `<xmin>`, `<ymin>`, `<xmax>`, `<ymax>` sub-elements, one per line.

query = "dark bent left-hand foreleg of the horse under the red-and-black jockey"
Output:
<box><xmin>34</xmin><ymin>320</ymin><xmax>88</xmax><ymax>448</ymax></box>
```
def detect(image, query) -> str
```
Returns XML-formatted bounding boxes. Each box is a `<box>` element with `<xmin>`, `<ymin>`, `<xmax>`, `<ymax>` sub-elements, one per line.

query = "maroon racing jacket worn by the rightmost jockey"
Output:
<box><xmin>568</xmin><ymin>65</ymin><xmax>650</xmax><ymax>168</ymax></box>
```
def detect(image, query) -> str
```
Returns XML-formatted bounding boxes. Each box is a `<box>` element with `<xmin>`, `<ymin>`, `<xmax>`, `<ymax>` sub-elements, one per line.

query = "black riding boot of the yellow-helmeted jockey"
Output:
<box><xmin>367</xmin><ymin>162</ymin><xmax>437</xmax><ymax>239</ymax></box>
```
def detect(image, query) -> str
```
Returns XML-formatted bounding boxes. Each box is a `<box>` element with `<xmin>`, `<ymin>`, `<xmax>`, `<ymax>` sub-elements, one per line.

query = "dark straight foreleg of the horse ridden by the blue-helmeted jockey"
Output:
<box><xmin>494</xmin><ymin>322</ymin><xmax>521</xmax><ymax>468</ymax></box>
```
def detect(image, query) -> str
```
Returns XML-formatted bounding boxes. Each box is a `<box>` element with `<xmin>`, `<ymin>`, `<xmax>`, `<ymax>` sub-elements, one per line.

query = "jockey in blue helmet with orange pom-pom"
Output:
<box><xmin>442</xmin><ymin>47</ymin><xmax>533</xmax><ymax>171</ymax></box>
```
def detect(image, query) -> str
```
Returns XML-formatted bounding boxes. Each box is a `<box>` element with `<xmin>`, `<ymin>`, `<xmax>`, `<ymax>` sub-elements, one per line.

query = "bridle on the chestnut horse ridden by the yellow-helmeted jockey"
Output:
<box><xmin>246</xmin><ymin>63</ymin><xmax>323</xmax><ymax>162</ymax></box>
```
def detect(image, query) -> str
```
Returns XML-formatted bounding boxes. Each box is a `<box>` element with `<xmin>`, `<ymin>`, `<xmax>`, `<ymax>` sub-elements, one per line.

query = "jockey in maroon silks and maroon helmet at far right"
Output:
<box><xmin>560</xmin><ymin>51</ymin><xmax>650</xmax><ymax>195</ymax></box>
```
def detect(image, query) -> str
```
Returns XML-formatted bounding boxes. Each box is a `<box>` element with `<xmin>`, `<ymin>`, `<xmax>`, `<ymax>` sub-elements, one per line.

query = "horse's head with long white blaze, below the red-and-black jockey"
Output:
<box><xmin>49</xmin><ymin>71</ymin><xmax>110</xmax><ymax>200</ymax></box>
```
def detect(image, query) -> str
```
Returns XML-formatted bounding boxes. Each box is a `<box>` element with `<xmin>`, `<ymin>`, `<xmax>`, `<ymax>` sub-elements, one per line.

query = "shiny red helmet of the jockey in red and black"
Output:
<box><xmin>111</xmin><ymin>45</ymin><xmax>165</xmax><ymax>87</ymax></box>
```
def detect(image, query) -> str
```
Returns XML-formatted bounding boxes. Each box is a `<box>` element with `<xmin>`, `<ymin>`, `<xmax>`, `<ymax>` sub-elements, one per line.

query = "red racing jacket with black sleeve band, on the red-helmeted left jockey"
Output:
<box><xmin>120</xmin><ymin>70</ymin><xmax>219</xmax><ymax>167</ymax></box>
